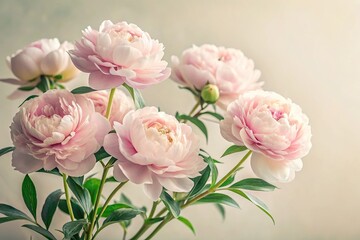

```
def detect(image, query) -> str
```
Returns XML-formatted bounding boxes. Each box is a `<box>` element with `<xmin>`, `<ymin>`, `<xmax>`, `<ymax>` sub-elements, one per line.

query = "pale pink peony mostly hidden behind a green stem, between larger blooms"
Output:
<box><xmin>83</xmin><ymin>90</ymin><xmax>135</xmax><ymax>126</ymax></box>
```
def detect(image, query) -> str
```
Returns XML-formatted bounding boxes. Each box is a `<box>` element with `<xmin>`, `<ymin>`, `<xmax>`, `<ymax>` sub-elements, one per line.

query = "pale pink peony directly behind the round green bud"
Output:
<box><xmin>171</xmin><ymin>44</ymin><xmax>263</xmax><ymax>109</ymax></box>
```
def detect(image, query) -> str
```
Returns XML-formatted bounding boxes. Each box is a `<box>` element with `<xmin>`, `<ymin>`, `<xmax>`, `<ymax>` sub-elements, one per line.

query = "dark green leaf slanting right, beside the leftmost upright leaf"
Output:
<box><xmin>41</xmin><ymin>189</ymin><xmax>63</xmax><ymax>229</ymax></box>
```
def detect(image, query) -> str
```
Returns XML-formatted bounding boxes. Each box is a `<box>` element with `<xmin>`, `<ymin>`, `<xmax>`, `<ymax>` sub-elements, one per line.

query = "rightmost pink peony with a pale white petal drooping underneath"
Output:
<box><xmin>220</xmin><ymin>90</ymin><xmax>311</xmax><ymax>182</ymax></box>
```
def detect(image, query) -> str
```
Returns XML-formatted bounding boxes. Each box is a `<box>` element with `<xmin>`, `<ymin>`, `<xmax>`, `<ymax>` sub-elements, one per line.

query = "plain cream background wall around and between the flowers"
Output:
<box><xmin>0</xmin><ymin>0</ymin><xmax>360</xmax><ymax>240</ymax></box>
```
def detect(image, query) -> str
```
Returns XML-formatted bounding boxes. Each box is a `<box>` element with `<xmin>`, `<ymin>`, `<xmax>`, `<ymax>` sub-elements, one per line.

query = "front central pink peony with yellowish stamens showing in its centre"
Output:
<box><xmin>104</xmin><ymin>107</ymin><xmax>206</xmax><ymax>201</ymax></box>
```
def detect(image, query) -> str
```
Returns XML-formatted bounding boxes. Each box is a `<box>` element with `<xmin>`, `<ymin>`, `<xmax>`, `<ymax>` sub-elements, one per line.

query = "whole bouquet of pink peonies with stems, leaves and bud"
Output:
<box><xmin>0</xmin><ymin>21</ymin><xmax>311</xmax><ymax>240</ymax></box>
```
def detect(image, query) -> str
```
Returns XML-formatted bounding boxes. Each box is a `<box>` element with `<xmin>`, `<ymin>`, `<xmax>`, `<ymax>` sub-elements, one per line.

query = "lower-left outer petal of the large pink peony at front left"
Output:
<box><xmin>12</xmin><ymin>149</ymin><xmax>43</xmax><ymax>173</ymax></box>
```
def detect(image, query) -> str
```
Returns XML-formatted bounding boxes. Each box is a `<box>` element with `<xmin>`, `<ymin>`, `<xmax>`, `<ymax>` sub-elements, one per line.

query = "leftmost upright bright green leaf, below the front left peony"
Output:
<box><xmin>22</xmin><ymin>174</ymin><xmax>37</xmax><ymax>220</ymax></box>
